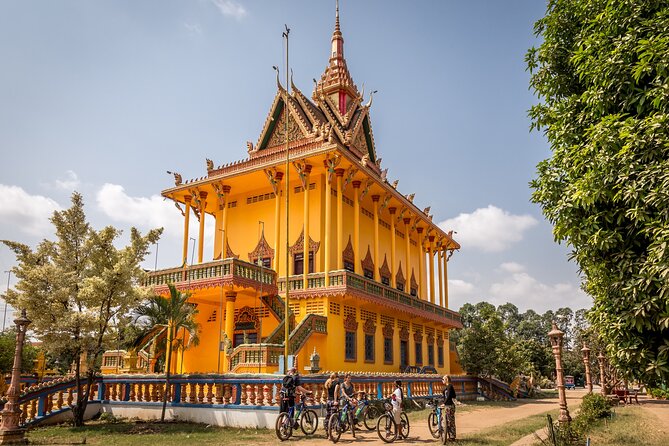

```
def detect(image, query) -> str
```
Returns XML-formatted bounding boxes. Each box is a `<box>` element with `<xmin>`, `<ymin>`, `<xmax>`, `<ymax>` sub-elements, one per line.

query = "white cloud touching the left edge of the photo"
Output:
<box><xmin>0</xmin><ymin>184</ymin><xmax>60</xmax><ymax>237</ymax></box>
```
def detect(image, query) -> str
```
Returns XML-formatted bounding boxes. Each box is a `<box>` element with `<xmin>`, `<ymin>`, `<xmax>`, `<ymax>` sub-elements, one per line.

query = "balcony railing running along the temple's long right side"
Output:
<box><xmin>277</xmin><ymin>270</ymin><xmax>462</xmax><ymax>327</ymax></box>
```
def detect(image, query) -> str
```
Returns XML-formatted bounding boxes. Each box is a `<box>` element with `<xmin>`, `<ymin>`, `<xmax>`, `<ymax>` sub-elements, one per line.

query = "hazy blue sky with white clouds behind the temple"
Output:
<box><xmin>0</xmin><ymin>0</ymin><xmax>591</xmax><ymax>328</ymax></box>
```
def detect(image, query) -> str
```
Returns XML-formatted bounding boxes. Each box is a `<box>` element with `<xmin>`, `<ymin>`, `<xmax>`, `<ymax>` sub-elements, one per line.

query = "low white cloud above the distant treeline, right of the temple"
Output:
<box><xmin>489</xmin><ymin>263</ymin><xmax>592</xmax><ymax>310</ymax></box>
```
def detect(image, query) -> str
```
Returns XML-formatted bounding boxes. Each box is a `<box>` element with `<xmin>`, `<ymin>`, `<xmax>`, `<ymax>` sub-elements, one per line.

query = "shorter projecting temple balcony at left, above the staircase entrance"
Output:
<box><xmin>144</xmin><ymin>258</ymin><xmax>277</xmax><ymax>294</ymax></box>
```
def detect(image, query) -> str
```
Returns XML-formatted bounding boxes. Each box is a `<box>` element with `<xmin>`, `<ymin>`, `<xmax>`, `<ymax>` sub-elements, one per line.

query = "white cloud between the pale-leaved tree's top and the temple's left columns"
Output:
<box><xmin>96</xmin><ymin>183</ymin><xmax>183</xmax><ymax>236</ymax></box>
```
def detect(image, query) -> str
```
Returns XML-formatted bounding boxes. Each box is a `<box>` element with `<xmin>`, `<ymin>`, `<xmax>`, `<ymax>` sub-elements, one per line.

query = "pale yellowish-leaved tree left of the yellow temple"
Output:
<box><xmin>3</xmin><ymin>193</ymin><xmax>162</xmax><ymax>426</ymax></box>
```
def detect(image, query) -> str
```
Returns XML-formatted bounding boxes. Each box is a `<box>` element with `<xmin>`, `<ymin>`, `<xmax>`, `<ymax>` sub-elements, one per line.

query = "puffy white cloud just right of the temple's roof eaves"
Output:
<box><xmin>439</xmin><ymin>205</ymin><xmax>537</xmax><ymax>252</ymax></box>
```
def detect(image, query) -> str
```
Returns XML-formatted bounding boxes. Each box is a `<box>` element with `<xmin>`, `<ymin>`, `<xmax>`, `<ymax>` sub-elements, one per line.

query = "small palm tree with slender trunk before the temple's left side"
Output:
<box><xmin>135</xmin><ymin>283</ymin><xmax>200</xmax><ymax>421</ymax></box>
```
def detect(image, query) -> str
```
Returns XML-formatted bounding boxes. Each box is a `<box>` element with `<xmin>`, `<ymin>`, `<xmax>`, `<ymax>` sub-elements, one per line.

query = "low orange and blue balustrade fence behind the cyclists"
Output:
<box><xmin>0</xmin><ymin>372</ymin><xmax>513</xmax><ymax>427</ymax></box>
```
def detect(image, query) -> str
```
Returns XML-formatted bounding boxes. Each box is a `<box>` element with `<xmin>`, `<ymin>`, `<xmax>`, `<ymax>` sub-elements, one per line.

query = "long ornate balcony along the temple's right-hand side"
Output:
<box><xmin>277</xmin><ymin>270</ymin><xmax>462</xmax><ymax>328</ymax></box>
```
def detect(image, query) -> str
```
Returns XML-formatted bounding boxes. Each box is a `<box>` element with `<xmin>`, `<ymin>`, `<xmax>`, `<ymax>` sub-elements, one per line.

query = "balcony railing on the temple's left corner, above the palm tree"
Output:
<box><xmin>144</xmin><ymin>258</ymin><xmax>276</xmax><ymax>292</ymax></box>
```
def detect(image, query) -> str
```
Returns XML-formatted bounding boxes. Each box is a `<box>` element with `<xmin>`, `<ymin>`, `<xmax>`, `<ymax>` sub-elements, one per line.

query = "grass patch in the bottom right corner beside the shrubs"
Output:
<box><xmin>587</xmin><ymin>407</ymin><xmax>669</xmax><ymax>446</ymax></box>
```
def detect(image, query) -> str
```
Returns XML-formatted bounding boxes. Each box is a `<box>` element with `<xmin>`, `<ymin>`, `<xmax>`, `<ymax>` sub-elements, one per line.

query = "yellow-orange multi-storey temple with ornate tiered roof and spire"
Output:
<box><xmin>148</xmin><ymin>6</ymin><xmax>462</xmax><ymax>373</ymax></box>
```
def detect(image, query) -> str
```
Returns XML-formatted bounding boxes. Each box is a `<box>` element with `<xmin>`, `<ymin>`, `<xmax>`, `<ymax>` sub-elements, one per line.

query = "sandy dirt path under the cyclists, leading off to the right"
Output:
<box><xmin>268</xmin><ymin>389</ymin><xmax>585</xmax><ymax>445</ymax></box>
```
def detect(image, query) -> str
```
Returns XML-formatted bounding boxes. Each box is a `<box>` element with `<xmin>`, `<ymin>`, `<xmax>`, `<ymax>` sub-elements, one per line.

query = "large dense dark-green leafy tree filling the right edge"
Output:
<box><xmin>526</xmin><ymin>0</ymin><xmax>669</xmax><ymax>383</ymax></box>
